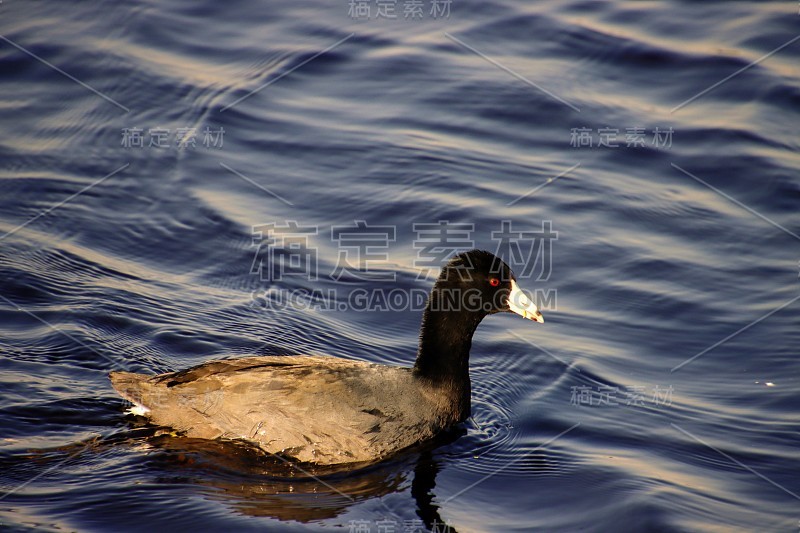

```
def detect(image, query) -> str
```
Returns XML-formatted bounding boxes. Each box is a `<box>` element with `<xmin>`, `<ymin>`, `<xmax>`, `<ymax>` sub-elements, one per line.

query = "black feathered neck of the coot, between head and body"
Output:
<box><xmin>414</xmin><ymin>286</ymin><xmax>485</xmax><ymax>388</ymax></box>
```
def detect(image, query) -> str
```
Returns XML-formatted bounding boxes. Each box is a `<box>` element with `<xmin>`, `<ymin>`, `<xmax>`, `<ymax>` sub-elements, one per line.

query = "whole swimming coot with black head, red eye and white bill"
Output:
<box><xmin>110</xmin><ymin>250</ymin><xmax>544</xmax><ymax>465</ymax></box>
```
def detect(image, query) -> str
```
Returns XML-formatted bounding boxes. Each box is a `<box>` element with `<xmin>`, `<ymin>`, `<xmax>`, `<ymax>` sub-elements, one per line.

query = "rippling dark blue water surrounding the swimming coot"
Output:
<box><xmin>0</xmin><ymin>0</ymin><xmax>800</xmax><ymax>531</ymax></box>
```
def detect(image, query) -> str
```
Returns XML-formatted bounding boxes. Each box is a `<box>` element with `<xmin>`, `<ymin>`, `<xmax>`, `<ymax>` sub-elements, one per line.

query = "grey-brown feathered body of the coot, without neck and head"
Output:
<box><xmin>111</xmin><ymin>356</ymin><xmax>469</xmax><ymax>465</ymax></box>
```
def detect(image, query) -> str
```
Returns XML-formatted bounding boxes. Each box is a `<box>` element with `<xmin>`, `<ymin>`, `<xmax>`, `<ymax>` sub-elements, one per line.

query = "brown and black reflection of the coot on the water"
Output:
<box><xmin>122</xmin><ymin>428</ymin><xmax>464</xmax><ymax>532</ymax></box>
